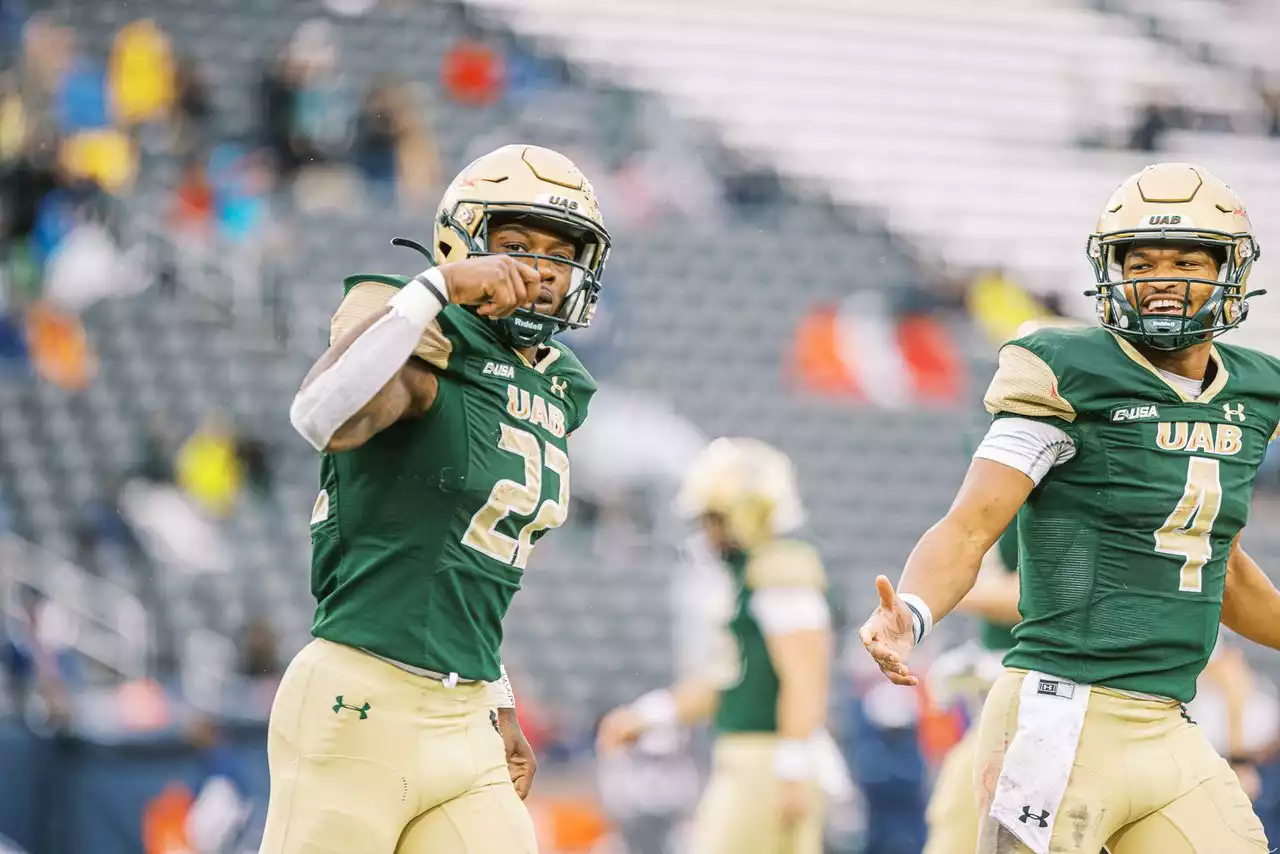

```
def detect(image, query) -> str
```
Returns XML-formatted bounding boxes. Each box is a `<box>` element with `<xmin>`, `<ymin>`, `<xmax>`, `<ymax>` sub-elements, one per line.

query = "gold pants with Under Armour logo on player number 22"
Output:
<box><xmin>260</xmin><ymin>640</ymin><xmax>538</xmax><ymax>854</ymax></box>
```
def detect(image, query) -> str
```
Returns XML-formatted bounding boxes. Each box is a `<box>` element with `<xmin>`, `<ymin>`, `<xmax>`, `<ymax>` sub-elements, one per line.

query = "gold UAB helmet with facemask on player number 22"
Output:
<box><xmin>431</xmin><ymin>145</ymin><xmax>609</xmax><ymax>347</ymax></box>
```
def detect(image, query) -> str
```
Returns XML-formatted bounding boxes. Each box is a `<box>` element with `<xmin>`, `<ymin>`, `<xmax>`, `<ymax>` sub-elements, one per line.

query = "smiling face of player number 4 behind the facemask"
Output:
<box><xmin>1123</xmin><ymin>241</ymin><xmax>1219</xmax><ymax>318</ymax></box>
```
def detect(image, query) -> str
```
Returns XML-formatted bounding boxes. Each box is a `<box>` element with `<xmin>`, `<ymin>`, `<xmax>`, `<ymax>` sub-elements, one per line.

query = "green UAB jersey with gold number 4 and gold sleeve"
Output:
<box><xmin>986</xmin><ymin>328</ymin><xmax>1280</xmax><ymax>702</ymax></box>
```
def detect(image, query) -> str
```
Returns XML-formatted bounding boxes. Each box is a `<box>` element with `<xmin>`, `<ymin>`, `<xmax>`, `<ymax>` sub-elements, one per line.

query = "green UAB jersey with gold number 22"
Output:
<box><xmin>311</xmin><ymin>275</ymin><xmax>595</xmax><ymax>681</ymax></box>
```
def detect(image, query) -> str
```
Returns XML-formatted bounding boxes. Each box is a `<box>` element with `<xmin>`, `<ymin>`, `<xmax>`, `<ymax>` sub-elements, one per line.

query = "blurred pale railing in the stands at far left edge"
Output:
<box><xmin>0</xmin><ymin>535</ymin><xmax>154</xmax><ymax>679</ymax></box>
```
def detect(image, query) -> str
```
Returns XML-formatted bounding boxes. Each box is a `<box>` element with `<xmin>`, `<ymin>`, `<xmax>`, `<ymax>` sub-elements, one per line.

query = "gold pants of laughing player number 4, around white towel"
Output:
<box><xmin>974</xmin><ymin>670</ymin><xmax>1267</xmax><ymax>854</ymax></box>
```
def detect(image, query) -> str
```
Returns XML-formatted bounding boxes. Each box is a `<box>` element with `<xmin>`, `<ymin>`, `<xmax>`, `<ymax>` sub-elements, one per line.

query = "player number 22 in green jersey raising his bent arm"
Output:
<box><xmin>261</xmin><ymin>146</ymin><xmax>609</xmax><ymax>854</ymax></box>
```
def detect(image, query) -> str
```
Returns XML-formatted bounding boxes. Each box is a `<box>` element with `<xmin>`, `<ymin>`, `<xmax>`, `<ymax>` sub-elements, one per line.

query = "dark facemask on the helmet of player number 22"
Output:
<box><xmin>440</xmin><ymin>198</ymin><xmax>611</xmax><ymax>348</ymax></box>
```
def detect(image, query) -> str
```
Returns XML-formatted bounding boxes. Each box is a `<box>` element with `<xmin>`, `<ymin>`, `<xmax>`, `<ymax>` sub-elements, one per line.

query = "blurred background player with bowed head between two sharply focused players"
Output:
<box><xmin>599</xmin><ymin>439</ymin><xmax>838</xmax><ymax>854</ymax></box>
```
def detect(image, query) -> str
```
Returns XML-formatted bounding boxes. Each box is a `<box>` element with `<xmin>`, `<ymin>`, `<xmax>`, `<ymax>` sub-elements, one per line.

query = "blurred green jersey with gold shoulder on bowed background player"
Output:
<box><xmin>713</xmin><ymin>540</ymin><xmax>826</xmax><ymax>732</ymax></box>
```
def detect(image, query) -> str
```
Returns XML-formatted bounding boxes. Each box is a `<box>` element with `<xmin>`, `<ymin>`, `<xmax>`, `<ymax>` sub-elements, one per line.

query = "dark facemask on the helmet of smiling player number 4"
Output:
<box><xmin>1088</xmin><ymin>228</ymin><xmax>1262</xmax><ymax>351</ymax></box>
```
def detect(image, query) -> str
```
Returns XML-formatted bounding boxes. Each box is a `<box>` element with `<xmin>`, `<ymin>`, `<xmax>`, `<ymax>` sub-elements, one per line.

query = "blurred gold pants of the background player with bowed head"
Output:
<box><xmin>689</xmin><ymin>732</ymin><xmax>823</xmax><ymax>854</ymax></box>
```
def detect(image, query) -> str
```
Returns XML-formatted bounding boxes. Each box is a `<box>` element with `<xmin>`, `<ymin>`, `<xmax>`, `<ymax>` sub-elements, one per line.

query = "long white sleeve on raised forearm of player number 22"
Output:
<box><xmin>289</xmin><ymin>269</ymin><xmax>447</xmax><ymax>451</ymax></box>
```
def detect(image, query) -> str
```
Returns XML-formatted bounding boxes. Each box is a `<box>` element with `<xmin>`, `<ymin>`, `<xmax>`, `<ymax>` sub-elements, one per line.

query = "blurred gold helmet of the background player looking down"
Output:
<box><xmin>677</xmin><ymin>438</ymin><xmax>804</xmax><ymax>549</ymax></box>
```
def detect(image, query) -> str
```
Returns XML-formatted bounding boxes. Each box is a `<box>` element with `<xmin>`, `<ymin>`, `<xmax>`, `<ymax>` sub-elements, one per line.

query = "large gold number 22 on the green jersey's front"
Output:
<box><xmin>462</xmin><ymin>424</ymin><xmax>568</xmax><ymax>570</ymax></box>
